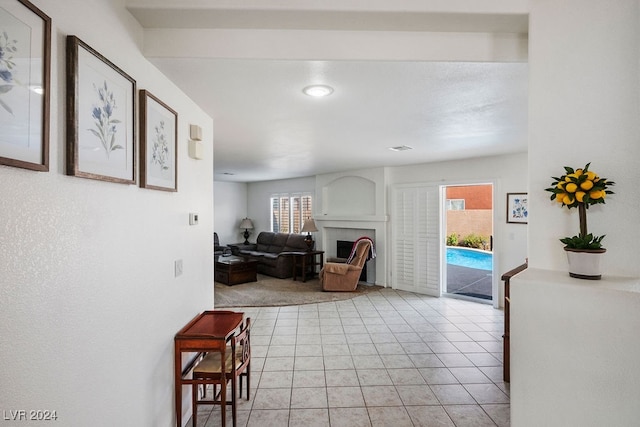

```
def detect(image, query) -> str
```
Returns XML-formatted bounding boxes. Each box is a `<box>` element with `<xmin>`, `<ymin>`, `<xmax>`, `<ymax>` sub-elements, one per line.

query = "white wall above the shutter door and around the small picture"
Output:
<box><xmin>388</xmin><ymin>153</ymin><xmax>528</xmax><ymax>306</ymax></box>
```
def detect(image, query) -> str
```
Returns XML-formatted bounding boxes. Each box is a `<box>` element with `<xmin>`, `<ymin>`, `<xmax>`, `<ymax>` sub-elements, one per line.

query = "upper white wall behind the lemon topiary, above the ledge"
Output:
<box><xmin>529</xmin><ymin>0</ymin><xmax>640</xmax><ymax>276</ymax></box>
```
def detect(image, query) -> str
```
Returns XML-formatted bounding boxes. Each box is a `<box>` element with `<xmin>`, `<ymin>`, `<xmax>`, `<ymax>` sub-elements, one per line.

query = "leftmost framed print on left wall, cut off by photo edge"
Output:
<box><xmin>0</xmin><ymin>0</ymin><xmax>51</xmax><ymax>172</ymax></box>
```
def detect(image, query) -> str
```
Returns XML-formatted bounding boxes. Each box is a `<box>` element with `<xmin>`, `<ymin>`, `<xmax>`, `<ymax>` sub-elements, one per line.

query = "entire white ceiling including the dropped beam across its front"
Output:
<box><xmin>129</xmin><ymin>0</ymin><xmax>528</xmax><ymax>182</ymax></box>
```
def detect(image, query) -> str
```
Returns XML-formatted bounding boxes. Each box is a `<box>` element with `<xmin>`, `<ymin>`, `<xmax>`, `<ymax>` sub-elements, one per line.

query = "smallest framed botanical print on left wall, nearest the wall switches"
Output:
<box><xmin>140</xmin><ymin>90</ymin><xmax>178</xmax><ymax>191</ymax></box>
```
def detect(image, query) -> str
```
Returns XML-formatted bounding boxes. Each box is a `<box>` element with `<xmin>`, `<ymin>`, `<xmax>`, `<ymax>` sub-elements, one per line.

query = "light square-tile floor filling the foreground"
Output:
<box><xmin>189</xmin><ymin>289</ymin><xmax>510</xmax><ymax>427</ymax></box>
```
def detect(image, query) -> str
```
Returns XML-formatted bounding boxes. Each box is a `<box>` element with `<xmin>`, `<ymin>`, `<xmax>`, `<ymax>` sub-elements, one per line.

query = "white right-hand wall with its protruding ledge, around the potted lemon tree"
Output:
<box><xmin>511</xmin><ymin>0</ymin><xmax>640</xmax><ymax>427</ymax></box>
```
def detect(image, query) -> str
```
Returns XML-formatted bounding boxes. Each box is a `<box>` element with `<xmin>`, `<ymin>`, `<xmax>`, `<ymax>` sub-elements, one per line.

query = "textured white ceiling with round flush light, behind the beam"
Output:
<box><xmin>153</xmin><ymin>59</ymin><xmax>527</xmax><ymax>181</ymax></box>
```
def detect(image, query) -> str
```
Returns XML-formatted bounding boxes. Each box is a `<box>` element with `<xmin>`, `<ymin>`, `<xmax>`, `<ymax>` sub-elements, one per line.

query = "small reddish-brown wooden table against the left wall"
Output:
<box><xmin>174</xmin><ymin>310</ymin><xmax>244</xmax><ymax>427</ymax></box>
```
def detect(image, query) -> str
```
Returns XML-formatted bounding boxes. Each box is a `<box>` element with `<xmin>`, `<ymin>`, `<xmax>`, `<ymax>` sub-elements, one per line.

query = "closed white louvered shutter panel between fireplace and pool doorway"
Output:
<box><xmin>391</xmin><ymin>185</ymin><xmax>440</xmax><ymax>296</ymax></box>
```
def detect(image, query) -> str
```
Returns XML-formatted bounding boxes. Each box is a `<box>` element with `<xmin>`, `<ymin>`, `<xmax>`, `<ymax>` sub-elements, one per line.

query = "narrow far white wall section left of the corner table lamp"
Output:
<box><xmin>213</xmin><ymin>181</ymin><xmax>246</xmax><ymax>245</ymax></box>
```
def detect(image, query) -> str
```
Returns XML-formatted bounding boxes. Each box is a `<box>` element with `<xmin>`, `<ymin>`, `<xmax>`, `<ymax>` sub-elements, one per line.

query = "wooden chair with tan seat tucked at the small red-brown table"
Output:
<box><xmin>192</xmin><ymin>318</ymin><xmax>251</xmax><ymax>427</ymax></box>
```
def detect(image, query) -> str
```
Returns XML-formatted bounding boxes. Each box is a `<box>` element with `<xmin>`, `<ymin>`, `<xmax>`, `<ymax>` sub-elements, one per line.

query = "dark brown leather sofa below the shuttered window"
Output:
<box><xmin>238</xmin><ymin>231</ymin><xmax>307</xmax><ymax>279</ymax></box>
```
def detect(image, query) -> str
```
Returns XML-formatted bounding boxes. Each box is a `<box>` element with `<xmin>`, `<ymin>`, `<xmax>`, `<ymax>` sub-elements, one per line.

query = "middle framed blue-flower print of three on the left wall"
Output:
<box><xmin>67</xmin><ymin>36</ymin><xmax>136</xmax><ymax>184</ymax></box>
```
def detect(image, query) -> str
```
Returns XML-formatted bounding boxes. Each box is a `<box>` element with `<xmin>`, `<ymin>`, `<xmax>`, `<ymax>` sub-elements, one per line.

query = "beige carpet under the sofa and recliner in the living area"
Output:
<box><xmin>214</xmin><ymin>274</ymin><xmax>383</xmax><ymax>308</ymax></box>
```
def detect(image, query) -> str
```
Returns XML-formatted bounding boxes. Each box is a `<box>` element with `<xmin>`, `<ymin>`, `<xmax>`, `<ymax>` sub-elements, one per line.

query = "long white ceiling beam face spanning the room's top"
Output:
<box><xmin>144</xmin><ymin>29</ymin><xmax>528</xmax><ymax>62</ymax></box>
